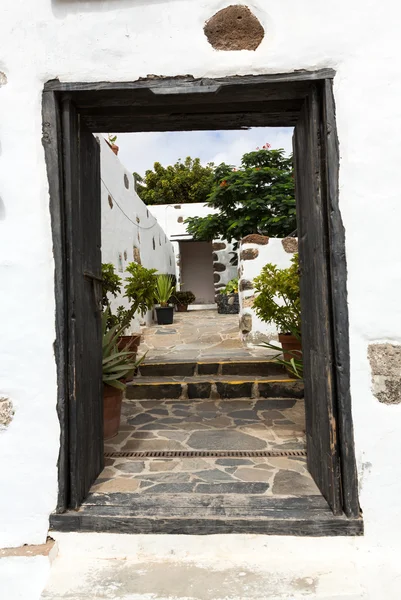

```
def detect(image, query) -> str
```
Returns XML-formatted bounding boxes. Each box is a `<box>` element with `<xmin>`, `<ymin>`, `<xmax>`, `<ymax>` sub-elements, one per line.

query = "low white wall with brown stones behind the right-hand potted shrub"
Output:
<box><xmin>238</xmin><ymin>234</ymin><xmax>297</xmax><ymax>345</ymax></box>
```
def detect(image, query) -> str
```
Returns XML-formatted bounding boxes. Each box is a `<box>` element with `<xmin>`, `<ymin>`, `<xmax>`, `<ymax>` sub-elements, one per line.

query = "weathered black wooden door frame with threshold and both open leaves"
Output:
<box><xmin>43</xmin><ymin>71</ymin><xmax>362</xmax><ymax>535</ymax></box>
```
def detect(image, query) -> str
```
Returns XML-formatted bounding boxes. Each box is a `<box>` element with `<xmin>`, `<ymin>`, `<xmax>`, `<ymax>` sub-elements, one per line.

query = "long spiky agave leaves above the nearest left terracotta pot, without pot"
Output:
<box><xmin>102</xmin><ymin>311</ymin><xmax>146</xmax><ymax>391</ymax></box>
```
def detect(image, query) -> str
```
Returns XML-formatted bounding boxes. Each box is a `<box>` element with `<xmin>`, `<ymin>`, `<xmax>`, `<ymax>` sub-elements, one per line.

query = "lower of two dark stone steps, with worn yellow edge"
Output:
<box><xmin>125</xmin><ymin>375</ymin><xmax>304</xmax><ymax>400</ymax></box>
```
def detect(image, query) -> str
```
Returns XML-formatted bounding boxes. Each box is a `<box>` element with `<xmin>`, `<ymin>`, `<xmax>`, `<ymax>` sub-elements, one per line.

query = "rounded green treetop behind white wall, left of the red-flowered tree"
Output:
<box><xmin>134</xmin><ymin>156</ymin><xmax>213</xmax><ymax>204</ymax></box>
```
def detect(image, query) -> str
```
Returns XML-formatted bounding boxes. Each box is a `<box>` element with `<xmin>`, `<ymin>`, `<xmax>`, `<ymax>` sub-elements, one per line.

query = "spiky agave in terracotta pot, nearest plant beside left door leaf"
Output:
<box><xmin>102</xmin><ymin>310</ymin><xmax>145</xmax><ymax>440</ymax></box>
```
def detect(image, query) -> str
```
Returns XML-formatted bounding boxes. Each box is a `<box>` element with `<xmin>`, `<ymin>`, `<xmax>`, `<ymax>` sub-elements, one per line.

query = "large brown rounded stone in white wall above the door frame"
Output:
<box><xmin>204</xmin><ymin>4</ymin><xmax>265</xmax><ymax>51</ymax></box>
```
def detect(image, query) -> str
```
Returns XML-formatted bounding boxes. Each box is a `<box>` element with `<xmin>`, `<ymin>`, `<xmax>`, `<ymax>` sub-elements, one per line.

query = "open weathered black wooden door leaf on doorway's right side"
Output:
<box><xmin>294</xmin><ymin>84</ymin><xmax>342</xmax><ymax>514</ymax></box>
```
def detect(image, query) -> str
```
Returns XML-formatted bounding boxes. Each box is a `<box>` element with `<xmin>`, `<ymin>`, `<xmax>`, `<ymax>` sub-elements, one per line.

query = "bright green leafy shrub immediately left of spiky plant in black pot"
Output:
<box><xmin>125</xmin><ymin>262</ymin><xmax>157</xmax><ymax>318</ymax></box>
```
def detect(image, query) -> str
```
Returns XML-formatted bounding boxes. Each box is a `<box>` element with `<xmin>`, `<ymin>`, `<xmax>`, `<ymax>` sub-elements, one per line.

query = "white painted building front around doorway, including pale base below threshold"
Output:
<box><xmin>0</xmin><ymin>0</ymin><xmax>401</xmax><ymax>600</ymax></box>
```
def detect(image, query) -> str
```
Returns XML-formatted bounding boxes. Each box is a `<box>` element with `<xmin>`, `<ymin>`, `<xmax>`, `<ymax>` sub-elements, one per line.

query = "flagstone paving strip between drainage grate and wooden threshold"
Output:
<box><xmin>91</xmin><ymin>457</ymin><xmax>319</xmax><ymax>496</ymax></box>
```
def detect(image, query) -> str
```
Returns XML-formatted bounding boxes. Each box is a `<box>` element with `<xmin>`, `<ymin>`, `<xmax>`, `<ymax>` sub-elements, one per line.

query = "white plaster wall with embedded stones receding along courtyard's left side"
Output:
<box><xmin>97</xmin><ymin>135</ymin><xmax>175</xmax><ymax>332</ymax></box>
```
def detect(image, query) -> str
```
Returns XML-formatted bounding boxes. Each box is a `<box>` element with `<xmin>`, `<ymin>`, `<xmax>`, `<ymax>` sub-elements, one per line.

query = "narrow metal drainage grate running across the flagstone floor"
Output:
<box><xmin>104</xmin><ymin>450</ymin><xmax>306</xmax><ymax>458</ymax></box>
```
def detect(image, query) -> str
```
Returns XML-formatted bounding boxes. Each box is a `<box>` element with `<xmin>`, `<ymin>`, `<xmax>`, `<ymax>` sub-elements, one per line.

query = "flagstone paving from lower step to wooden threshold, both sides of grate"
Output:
<box><xmin>92</xmin><ymin>398</ymin><xmax>319</xmax><ymax>496</ymax></box>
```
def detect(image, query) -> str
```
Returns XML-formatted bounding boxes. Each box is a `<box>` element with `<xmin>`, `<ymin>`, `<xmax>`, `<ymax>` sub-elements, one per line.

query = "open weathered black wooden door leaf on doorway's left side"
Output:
<box><xmin>62</xmin><ymin>98</ymin><xmax>104</xmax><ymax>508</ymax></box>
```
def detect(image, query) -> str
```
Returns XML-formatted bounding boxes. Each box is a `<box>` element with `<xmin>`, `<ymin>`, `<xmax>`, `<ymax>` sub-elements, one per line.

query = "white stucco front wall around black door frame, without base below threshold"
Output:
<box><xmin>0</xmin><ymin>0</ymin><xmax>401</xmax><ymax>600</ymax></box>
